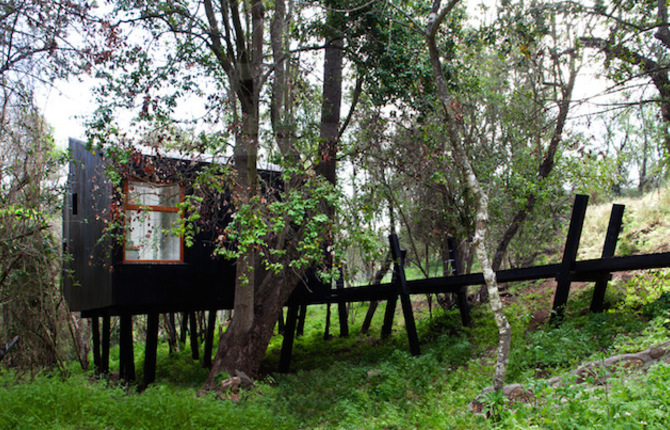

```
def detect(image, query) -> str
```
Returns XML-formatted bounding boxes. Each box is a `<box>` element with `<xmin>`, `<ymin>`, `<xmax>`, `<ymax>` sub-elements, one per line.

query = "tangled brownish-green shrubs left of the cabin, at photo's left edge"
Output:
<box><xmin>0</xmin><ymin>94</ymin><xmax>71</xmax><ymax>370</ymax></box>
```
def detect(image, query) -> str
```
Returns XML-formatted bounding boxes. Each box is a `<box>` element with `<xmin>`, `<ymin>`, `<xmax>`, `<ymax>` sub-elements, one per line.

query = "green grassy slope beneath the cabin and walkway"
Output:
<box><xmin>0</xmin><ymin>193</ymin><xmax>670</xmax><ymax>429</ymax></box>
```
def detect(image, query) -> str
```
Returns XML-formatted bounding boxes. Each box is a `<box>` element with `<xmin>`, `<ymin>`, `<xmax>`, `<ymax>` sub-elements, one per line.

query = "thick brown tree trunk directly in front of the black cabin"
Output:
<box><xmin>205</xmin><ymin>0</ymin><xmax>266</xmax><ymax>385</ymax></box>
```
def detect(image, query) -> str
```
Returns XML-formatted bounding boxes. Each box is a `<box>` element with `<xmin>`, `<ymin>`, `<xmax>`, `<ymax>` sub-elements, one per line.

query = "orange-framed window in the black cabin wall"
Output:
<box><xmin>123</xmin><ymin>181</ymin><xmax>183</xmax><ymax>262</ymax></box>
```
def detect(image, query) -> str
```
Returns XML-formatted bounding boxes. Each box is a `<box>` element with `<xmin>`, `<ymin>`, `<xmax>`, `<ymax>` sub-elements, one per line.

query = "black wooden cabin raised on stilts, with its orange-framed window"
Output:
<box><xmin>63</xmin><ymin>139</ymin><xmax>279</xmax><ymax>381</ymax></box>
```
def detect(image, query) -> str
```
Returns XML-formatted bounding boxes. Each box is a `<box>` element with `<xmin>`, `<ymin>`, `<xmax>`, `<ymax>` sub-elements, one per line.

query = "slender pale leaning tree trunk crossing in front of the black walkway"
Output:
<box><xmin>426</xmin><ymin>0</ymin><xmax>512</xmax><ymax>391</ymax></box>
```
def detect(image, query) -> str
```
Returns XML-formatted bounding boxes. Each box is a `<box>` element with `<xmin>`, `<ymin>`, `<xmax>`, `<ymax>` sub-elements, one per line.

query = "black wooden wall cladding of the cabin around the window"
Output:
<box><xmin>63</xmin><ymin>139</ymin><xmax>255</xmax><ymax>317</ymax></box>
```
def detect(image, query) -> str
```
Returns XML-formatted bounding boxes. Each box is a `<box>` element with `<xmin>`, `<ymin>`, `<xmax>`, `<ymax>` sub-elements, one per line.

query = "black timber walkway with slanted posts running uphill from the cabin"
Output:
<box><xmin>279</xmin><ymin>195</ymin><xmax>670</xmax><ymax>372</ymax></box>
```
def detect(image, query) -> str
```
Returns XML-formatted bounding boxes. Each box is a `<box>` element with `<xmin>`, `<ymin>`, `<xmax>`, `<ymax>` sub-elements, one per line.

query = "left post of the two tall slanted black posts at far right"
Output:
<box><xmin>551</xmin><ymin>194</ymin><xmax>589</xmax><ymax>324</ymax></box>
